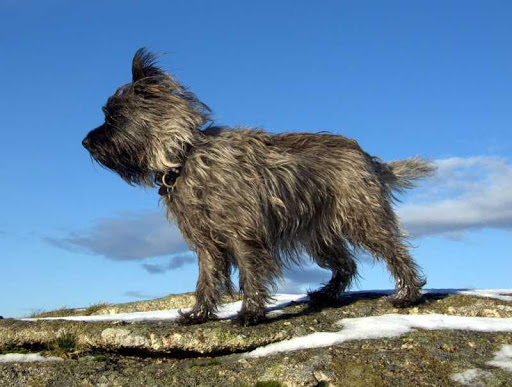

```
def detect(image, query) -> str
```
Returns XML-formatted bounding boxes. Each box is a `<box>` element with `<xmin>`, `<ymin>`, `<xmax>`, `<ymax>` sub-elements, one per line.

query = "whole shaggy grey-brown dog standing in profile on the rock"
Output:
<box><xmin>83</xmin><ymin>49</ymin><xmax>434</xmax><ymax>325</ymax></box>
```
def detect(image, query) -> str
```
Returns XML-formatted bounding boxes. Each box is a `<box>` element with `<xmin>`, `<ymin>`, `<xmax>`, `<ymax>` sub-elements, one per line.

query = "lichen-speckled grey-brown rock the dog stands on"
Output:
<box><xmin>0</xmin><ymin>293</ymin><xmax>512</xmax><ymax>386</ymax></box>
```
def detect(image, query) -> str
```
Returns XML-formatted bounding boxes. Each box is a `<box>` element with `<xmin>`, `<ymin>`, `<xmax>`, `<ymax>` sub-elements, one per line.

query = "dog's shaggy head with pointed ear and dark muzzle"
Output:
<box><xmin>82</xmin><ymin>48</ymin><xmax>210</xmax><ymax>186</ymax></box>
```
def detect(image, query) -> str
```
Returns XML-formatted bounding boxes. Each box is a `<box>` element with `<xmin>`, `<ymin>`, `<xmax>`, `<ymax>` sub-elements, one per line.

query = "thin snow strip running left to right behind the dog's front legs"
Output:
<box><xmin>22</xmin><ymin>294</ymin><xmax>307</xmax><ymax>322</ymax></box>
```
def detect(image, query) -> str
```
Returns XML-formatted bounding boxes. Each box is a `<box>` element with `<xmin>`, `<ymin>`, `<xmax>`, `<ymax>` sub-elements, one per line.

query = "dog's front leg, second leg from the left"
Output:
<box><xmin>233</xmin><ymin>240</ymin><xmax>281</xmax><ymax>326</ymax></box>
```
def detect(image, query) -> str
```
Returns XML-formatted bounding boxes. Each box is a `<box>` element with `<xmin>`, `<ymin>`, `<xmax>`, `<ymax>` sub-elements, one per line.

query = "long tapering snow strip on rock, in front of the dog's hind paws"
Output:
<box><xmin>245</xmin><ymin>314</ymin><xmax>512</xmax><ymax>358</ymax></box>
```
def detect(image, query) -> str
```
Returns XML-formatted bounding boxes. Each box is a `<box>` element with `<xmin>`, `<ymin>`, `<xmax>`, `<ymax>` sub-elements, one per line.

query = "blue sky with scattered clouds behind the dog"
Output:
<box><xmin>0</xmin><ymin>0</ymin><xmax>512</xmax><ymax>317</ymax></box>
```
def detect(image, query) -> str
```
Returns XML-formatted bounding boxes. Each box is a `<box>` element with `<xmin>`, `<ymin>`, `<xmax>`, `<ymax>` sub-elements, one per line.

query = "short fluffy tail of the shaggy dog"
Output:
<box><xmin>381</xmin><ymin>157</ymin><xmax>437</xmax><ymax>192</ymax></box>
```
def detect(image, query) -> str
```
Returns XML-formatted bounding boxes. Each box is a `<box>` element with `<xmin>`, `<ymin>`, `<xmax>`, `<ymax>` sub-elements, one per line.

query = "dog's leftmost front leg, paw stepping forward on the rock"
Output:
<box><xmin>178</xmin><ymin>246</ymin><xmax>225</xmax><ymax>324</ymax></box>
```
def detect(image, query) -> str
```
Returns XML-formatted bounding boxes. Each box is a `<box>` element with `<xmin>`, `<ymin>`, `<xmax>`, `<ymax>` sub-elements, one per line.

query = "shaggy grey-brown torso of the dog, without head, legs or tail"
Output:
<box><xmin>170</xmin><ymin>128</ymin><xmax>428</xmax><ymax>257</ymax></box>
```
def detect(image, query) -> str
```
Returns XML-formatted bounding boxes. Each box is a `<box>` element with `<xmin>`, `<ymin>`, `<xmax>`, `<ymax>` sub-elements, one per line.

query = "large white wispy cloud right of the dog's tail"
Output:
<box><xmin>398</xmin><ymin>157</ymin><xmax>512</xmax><ymax>239</ymax></box>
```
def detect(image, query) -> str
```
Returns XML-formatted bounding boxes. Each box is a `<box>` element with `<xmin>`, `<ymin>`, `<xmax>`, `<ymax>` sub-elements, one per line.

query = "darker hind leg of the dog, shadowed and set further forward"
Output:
<box><xmin>306</xmin><ymin>238</ymin><xmax>357</xmax><ymax>306</ymax></box>
